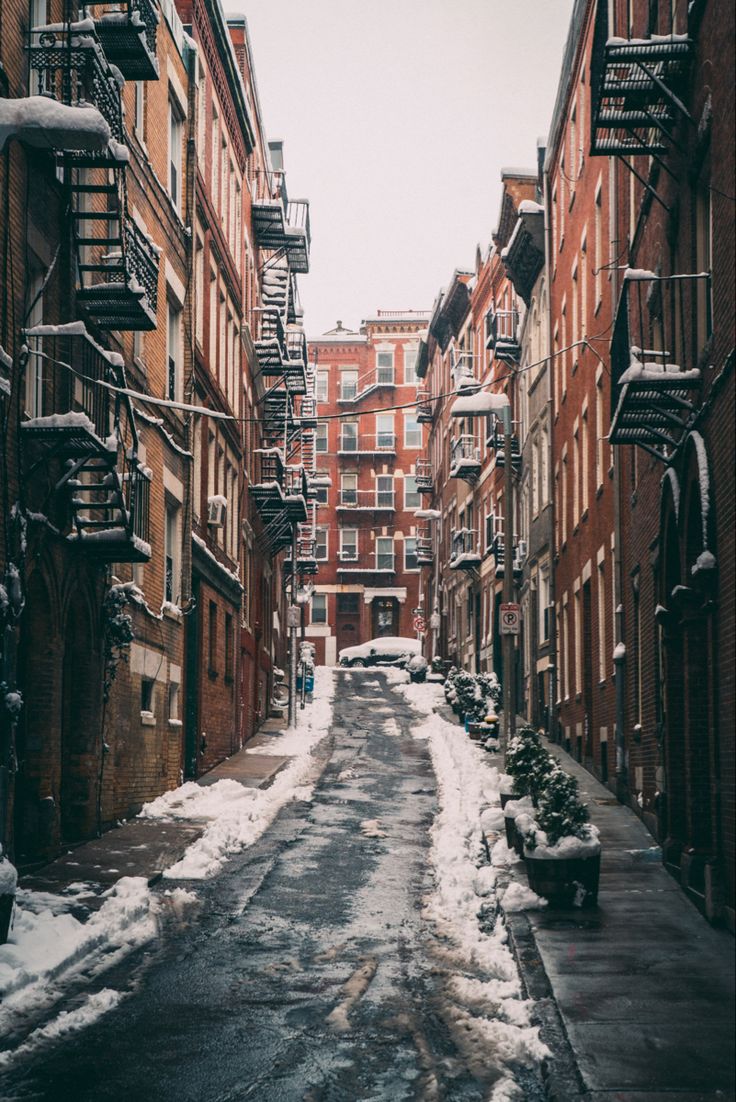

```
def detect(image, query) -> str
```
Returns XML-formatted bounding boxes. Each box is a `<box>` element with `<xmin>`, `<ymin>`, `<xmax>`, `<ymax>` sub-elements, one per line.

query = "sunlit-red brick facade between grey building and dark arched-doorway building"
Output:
<box><xmin>545</xmin><ymin>4</ymin><xmax>626</xmax><ymax>782</ymax></box>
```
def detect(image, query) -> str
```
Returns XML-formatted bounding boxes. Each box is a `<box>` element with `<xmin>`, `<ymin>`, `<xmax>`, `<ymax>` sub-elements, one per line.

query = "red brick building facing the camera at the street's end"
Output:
<box><xmin>305</xmin><ymin>310</ymin><xmax>427</xmax><ymax>665</ymax></box>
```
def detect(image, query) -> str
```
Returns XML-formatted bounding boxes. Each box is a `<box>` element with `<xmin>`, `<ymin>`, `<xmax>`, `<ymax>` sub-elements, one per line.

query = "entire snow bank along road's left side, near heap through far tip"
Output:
<box><xmin>0</xmin><ymin>669</ymin><xmax>334</xmax><ymax>1049</ymax></box>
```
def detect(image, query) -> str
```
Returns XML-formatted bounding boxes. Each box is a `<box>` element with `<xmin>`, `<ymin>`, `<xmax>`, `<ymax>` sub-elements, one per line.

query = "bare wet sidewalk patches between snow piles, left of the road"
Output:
<box><xmin>19</xmin><ymin>720</ymin><xmax>291</xmax><ymax>903</ymax></box>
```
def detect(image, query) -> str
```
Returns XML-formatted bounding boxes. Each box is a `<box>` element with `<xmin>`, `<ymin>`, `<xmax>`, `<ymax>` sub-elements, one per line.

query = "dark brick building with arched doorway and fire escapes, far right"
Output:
<box><xmin>586</xmin><ymin>2</ymin><xmax>736</xmax><ymax>929</ymax></box>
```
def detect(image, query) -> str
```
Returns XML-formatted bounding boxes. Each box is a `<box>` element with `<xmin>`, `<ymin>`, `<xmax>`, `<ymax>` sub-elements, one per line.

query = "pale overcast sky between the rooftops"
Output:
<box><xmin>235</xmin><ymin>0</ymin><xmax>572</xmax><ymax>336</ymax></box>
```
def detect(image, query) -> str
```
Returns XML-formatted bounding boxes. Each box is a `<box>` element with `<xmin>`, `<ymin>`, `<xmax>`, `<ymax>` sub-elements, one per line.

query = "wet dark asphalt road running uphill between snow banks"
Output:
<box><xmin>0</xmin><ymin>671</ymin><xmax>506</xmax><ymax>1102</ymax></box>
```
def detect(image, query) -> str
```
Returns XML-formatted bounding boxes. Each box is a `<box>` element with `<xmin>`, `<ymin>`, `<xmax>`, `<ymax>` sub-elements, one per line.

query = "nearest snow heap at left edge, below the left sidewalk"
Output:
<box><xmin>0</xmin><ymin>876</ymin><xmax>159</xmax><ymax>1041</ymax></box>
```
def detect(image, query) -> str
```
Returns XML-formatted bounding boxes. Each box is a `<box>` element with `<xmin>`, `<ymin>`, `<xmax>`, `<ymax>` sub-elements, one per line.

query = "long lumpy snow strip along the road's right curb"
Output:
<box><xmin>396</xmin><ymin>683</ymin><xmax>549</xmax><ymax>1102</ymax></box>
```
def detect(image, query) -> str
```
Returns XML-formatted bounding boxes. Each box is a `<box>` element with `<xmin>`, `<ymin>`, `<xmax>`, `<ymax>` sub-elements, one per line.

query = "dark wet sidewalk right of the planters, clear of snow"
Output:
<box><xmin>506</xmin><ymin>744</ymin><xmax>736</xmax><ymax>1102</ymax></box>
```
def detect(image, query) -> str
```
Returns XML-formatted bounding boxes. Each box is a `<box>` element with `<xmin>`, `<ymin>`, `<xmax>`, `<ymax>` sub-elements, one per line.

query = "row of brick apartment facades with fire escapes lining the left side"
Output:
<box><xmin>0</xmin><ymin>2</ymin><xmax>314</xmax><ymax>865</ymax></box>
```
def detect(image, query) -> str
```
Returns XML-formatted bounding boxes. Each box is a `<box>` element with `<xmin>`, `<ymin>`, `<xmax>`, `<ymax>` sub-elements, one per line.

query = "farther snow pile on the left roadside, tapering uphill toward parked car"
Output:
<box><xmin>141</xmin><ymin>667</ymin><xmax>335</xmax><ymax>880</ymax></box>
